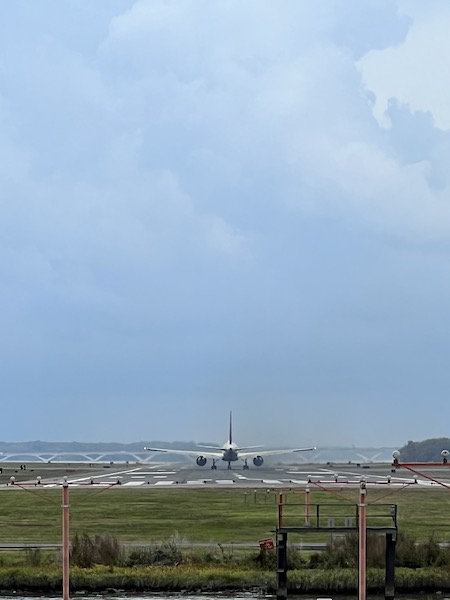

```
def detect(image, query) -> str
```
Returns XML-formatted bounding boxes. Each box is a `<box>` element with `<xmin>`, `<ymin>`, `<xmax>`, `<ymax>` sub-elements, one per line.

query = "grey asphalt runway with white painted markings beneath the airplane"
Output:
<box><xmin>6</xmin><ymin>462</ymin><xmax>450</xmax><ymax>490</ymax></box>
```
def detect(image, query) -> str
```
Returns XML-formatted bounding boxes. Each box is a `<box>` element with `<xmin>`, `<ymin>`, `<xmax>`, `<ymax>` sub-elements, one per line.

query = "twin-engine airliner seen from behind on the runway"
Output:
<box><xmin>144</xmin><ymin>411</ymin><xmax>317</xmax><ymax>469</ymax></box>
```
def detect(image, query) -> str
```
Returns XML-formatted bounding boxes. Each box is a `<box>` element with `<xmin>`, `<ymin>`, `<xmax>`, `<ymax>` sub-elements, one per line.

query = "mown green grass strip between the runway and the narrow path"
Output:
<box><xmin>0</xmin><ymin>486</ymin><xmax>450</xmax><ymax>544</ymax></box>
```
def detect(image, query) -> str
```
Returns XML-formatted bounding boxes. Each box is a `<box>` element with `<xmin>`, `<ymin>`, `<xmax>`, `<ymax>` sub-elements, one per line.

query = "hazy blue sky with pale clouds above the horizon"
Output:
<box><xmin>0</xmin><ymin>0</ymin><xmax>450</xmax><ymax>447</ymax></box>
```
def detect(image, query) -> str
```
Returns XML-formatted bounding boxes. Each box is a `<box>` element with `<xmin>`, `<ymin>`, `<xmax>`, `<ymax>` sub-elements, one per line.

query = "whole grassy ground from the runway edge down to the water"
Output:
<box><xmin>0</xmin><ymin>486</ymin><xmax>450</xmax><ymax>593</ymax></box>
